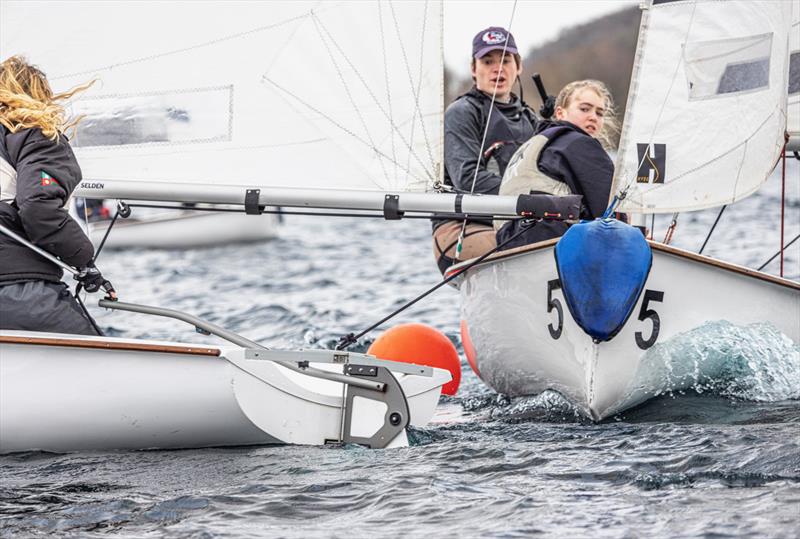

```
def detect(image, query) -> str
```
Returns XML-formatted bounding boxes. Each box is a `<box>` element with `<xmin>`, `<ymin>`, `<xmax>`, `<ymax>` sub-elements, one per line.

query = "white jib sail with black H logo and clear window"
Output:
<box><xmin>612</xmin><ymin>0</ymin><xmax>792</xmax><ymax>213</ymax></box>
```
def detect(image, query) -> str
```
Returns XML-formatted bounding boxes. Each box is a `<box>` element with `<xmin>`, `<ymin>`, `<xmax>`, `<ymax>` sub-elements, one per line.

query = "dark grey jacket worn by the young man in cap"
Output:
<box><xmin>433</xmin><ymin>87</ymin><xmax>537</xmax><ymax>229</ymax></box>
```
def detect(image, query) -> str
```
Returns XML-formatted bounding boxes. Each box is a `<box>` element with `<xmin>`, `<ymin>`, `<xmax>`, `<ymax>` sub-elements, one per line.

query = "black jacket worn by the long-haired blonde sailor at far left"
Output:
<box><xmin>0</xmin><ymin>124</ymin><xmax>94</xmax><ymax>286</ymax></box>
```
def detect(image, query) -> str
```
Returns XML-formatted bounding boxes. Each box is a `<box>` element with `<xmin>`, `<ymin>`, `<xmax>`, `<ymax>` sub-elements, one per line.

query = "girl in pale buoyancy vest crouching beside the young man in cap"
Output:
<box><xmin>494</xmin><ymin>80</ymin><xmax>617</xmax><ymax>249</ymax></box>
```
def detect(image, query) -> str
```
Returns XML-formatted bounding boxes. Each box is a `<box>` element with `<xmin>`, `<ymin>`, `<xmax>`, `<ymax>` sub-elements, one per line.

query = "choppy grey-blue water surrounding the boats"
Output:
<box><xmin>0</xmin><ymin>163</ymin><xmax>800</xmax><ymax>538</ymax></box>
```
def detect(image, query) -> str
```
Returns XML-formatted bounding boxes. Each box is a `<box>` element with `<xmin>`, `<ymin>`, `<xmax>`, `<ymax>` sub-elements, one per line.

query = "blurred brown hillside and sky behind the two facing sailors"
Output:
<box><xmin>444</xmin><ymin>6</ymin><xmax>641</xmax><ymax>149</ymax></box>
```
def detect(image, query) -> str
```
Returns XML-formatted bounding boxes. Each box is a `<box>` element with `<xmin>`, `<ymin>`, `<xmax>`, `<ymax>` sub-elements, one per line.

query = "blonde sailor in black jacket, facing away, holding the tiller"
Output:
<box><xmin>0</xmin><ymin>56</ymin><xmax>110</xmax><ymax>335</ymax></box>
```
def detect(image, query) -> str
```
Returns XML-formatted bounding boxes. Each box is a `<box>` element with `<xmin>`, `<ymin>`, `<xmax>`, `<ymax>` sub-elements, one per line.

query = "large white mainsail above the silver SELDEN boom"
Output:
<box><xmin>0</xmin><ymin>1</ymin><xmax>443</xmax><ymax>191</ymax></box>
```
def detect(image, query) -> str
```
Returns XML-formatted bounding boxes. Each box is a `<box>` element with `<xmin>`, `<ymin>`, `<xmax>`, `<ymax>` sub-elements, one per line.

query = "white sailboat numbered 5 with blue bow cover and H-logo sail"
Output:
<box><xmin>453</xmin><ymin>0</ymin><xmax>800</xmax><ymax>419</ymax></box>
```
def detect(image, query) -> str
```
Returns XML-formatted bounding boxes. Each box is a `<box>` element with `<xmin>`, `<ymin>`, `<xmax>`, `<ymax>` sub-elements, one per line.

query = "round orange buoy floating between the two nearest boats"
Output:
<box><xmin>367</xmin><ymin>324</ymin><xmax>461</xmax><ymax>395</ymax></box>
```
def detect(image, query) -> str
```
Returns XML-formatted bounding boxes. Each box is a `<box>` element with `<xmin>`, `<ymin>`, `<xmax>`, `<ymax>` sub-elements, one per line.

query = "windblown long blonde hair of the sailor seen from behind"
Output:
<box><xmin>0</xmin><ymin>56</ymin><xmax>94</xmax><ymax>141</ymax></box>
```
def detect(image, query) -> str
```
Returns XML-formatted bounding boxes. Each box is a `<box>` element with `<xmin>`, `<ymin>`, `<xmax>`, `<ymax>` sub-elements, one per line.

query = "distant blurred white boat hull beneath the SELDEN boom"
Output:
<box><xmin>89</xmin><ymin>211</ymin><xmax>278</xmax><ymax>249</ymax></box>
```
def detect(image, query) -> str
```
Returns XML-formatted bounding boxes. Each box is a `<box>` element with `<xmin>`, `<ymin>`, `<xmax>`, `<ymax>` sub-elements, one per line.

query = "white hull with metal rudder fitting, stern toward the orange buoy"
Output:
<box><xmin>0</xmin><ymin>331</ymin><xmax>450</xmax><ymax>453</ymax></box>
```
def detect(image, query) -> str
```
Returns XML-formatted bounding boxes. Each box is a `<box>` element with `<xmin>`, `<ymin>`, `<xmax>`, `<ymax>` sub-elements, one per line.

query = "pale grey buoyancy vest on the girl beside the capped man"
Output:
<box><xmin>494</xmin><ymin>126</ymin><xmax>574</xmax><ymax>230</ymax></box>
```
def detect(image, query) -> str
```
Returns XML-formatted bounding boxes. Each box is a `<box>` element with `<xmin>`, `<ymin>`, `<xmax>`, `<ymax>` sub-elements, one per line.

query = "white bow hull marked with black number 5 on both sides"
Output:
<box><xmin>459</xmin><ymin>241</ymin><xmax>800</xmax><ymax>419</ymax></box>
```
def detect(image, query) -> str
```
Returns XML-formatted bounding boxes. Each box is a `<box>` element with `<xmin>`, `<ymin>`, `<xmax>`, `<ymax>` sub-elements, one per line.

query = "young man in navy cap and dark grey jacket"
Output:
<box><xmin>433</xmin><ymin>26</ymin><xmax>537</xmax><ymax>273</ymax></box>
